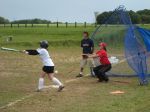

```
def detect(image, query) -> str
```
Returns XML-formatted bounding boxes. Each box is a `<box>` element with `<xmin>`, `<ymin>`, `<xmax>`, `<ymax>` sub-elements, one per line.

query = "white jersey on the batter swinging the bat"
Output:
<box><xmin>37</xmin><ymin>48</ymin><xmax>54</xmax><ymax>66</ymax></box>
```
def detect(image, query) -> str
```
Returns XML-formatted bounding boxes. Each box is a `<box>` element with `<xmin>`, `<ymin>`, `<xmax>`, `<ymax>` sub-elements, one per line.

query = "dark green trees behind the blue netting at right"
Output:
<box><xmin>96</xmin><ymin>9</ymin><xmax>150</xmax><ymax>24</ymax></box>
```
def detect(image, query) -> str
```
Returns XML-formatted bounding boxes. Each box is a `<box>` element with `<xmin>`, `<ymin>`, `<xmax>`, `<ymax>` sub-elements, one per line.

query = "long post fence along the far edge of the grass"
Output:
<box><xmin>0</xmin><ymin>22</ymin><xmax>97</xmax><ymax>28</ymax></box>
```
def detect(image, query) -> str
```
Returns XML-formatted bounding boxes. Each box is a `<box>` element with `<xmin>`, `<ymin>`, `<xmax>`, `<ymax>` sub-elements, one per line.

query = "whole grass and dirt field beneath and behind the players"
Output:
<box><xmin>0</xmin><ymin>25</ymin><xmax>150</xmax><ymax>112</ymax></box>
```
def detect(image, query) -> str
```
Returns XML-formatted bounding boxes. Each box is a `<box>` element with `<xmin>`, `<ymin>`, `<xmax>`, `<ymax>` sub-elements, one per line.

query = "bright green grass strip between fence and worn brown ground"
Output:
<box><xmin>0</xmin><ymin>27</ymin><xmax>94</xmax><ymax>47</ymax></box>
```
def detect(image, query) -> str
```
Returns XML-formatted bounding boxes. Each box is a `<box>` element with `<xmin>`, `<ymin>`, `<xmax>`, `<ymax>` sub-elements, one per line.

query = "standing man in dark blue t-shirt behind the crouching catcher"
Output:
<box><xmin>76</xmin><ymin>32</ymin><xmax>94</xmax><ymax>77</ymax></box>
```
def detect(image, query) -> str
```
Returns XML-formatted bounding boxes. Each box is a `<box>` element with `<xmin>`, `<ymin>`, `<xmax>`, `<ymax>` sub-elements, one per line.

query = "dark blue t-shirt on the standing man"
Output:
<box><xmin>81</xmin><ymin>38</ymin><xmax>94</xmax><ymax>54</ymax></box>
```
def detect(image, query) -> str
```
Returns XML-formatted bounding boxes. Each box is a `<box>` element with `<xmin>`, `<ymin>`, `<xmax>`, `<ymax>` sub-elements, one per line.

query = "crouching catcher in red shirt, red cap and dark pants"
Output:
<box><xmin>85</xmin><ymin>42</ymin><xmax>111</xmax><ymax>82</ymax></box>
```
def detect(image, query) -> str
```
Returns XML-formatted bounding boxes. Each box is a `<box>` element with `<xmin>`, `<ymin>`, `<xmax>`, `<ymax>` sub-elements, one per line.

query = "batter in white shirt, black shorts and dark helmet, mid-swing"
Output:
<box><xmin>23</xmin><ymin>41</ymin><xmax>64</xmax><ymax>91</ymax></box>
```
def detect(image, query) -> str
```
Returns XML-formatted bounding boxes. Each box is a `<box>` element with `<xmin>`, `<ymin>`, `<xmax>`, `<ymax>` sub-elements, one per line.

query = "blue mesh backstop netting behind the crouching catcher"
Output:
<box><xmin>91</xmin><ymin>6</ymin><xmax>150</xmax><ymax>84</ymax></box>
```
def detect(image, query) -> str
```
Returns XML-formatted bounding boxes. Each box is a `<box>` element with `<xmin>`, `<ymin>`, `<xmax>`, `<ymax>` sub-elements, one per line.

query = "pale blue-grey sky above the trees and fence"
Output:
<box><xmin>0</xmin><ymin>0</ymin><xmax>150</xmax><ymax>23</ymax></box>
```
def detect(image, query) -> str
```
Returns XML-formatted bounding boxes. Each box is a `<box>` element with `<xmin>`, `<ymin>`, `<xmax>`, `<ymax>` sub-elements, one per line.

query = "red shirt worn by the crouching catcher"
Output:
<box><xmin>96</xmin><ymin>49</ymin><xmax>111</xmax><ymax>65</ymax></box>
